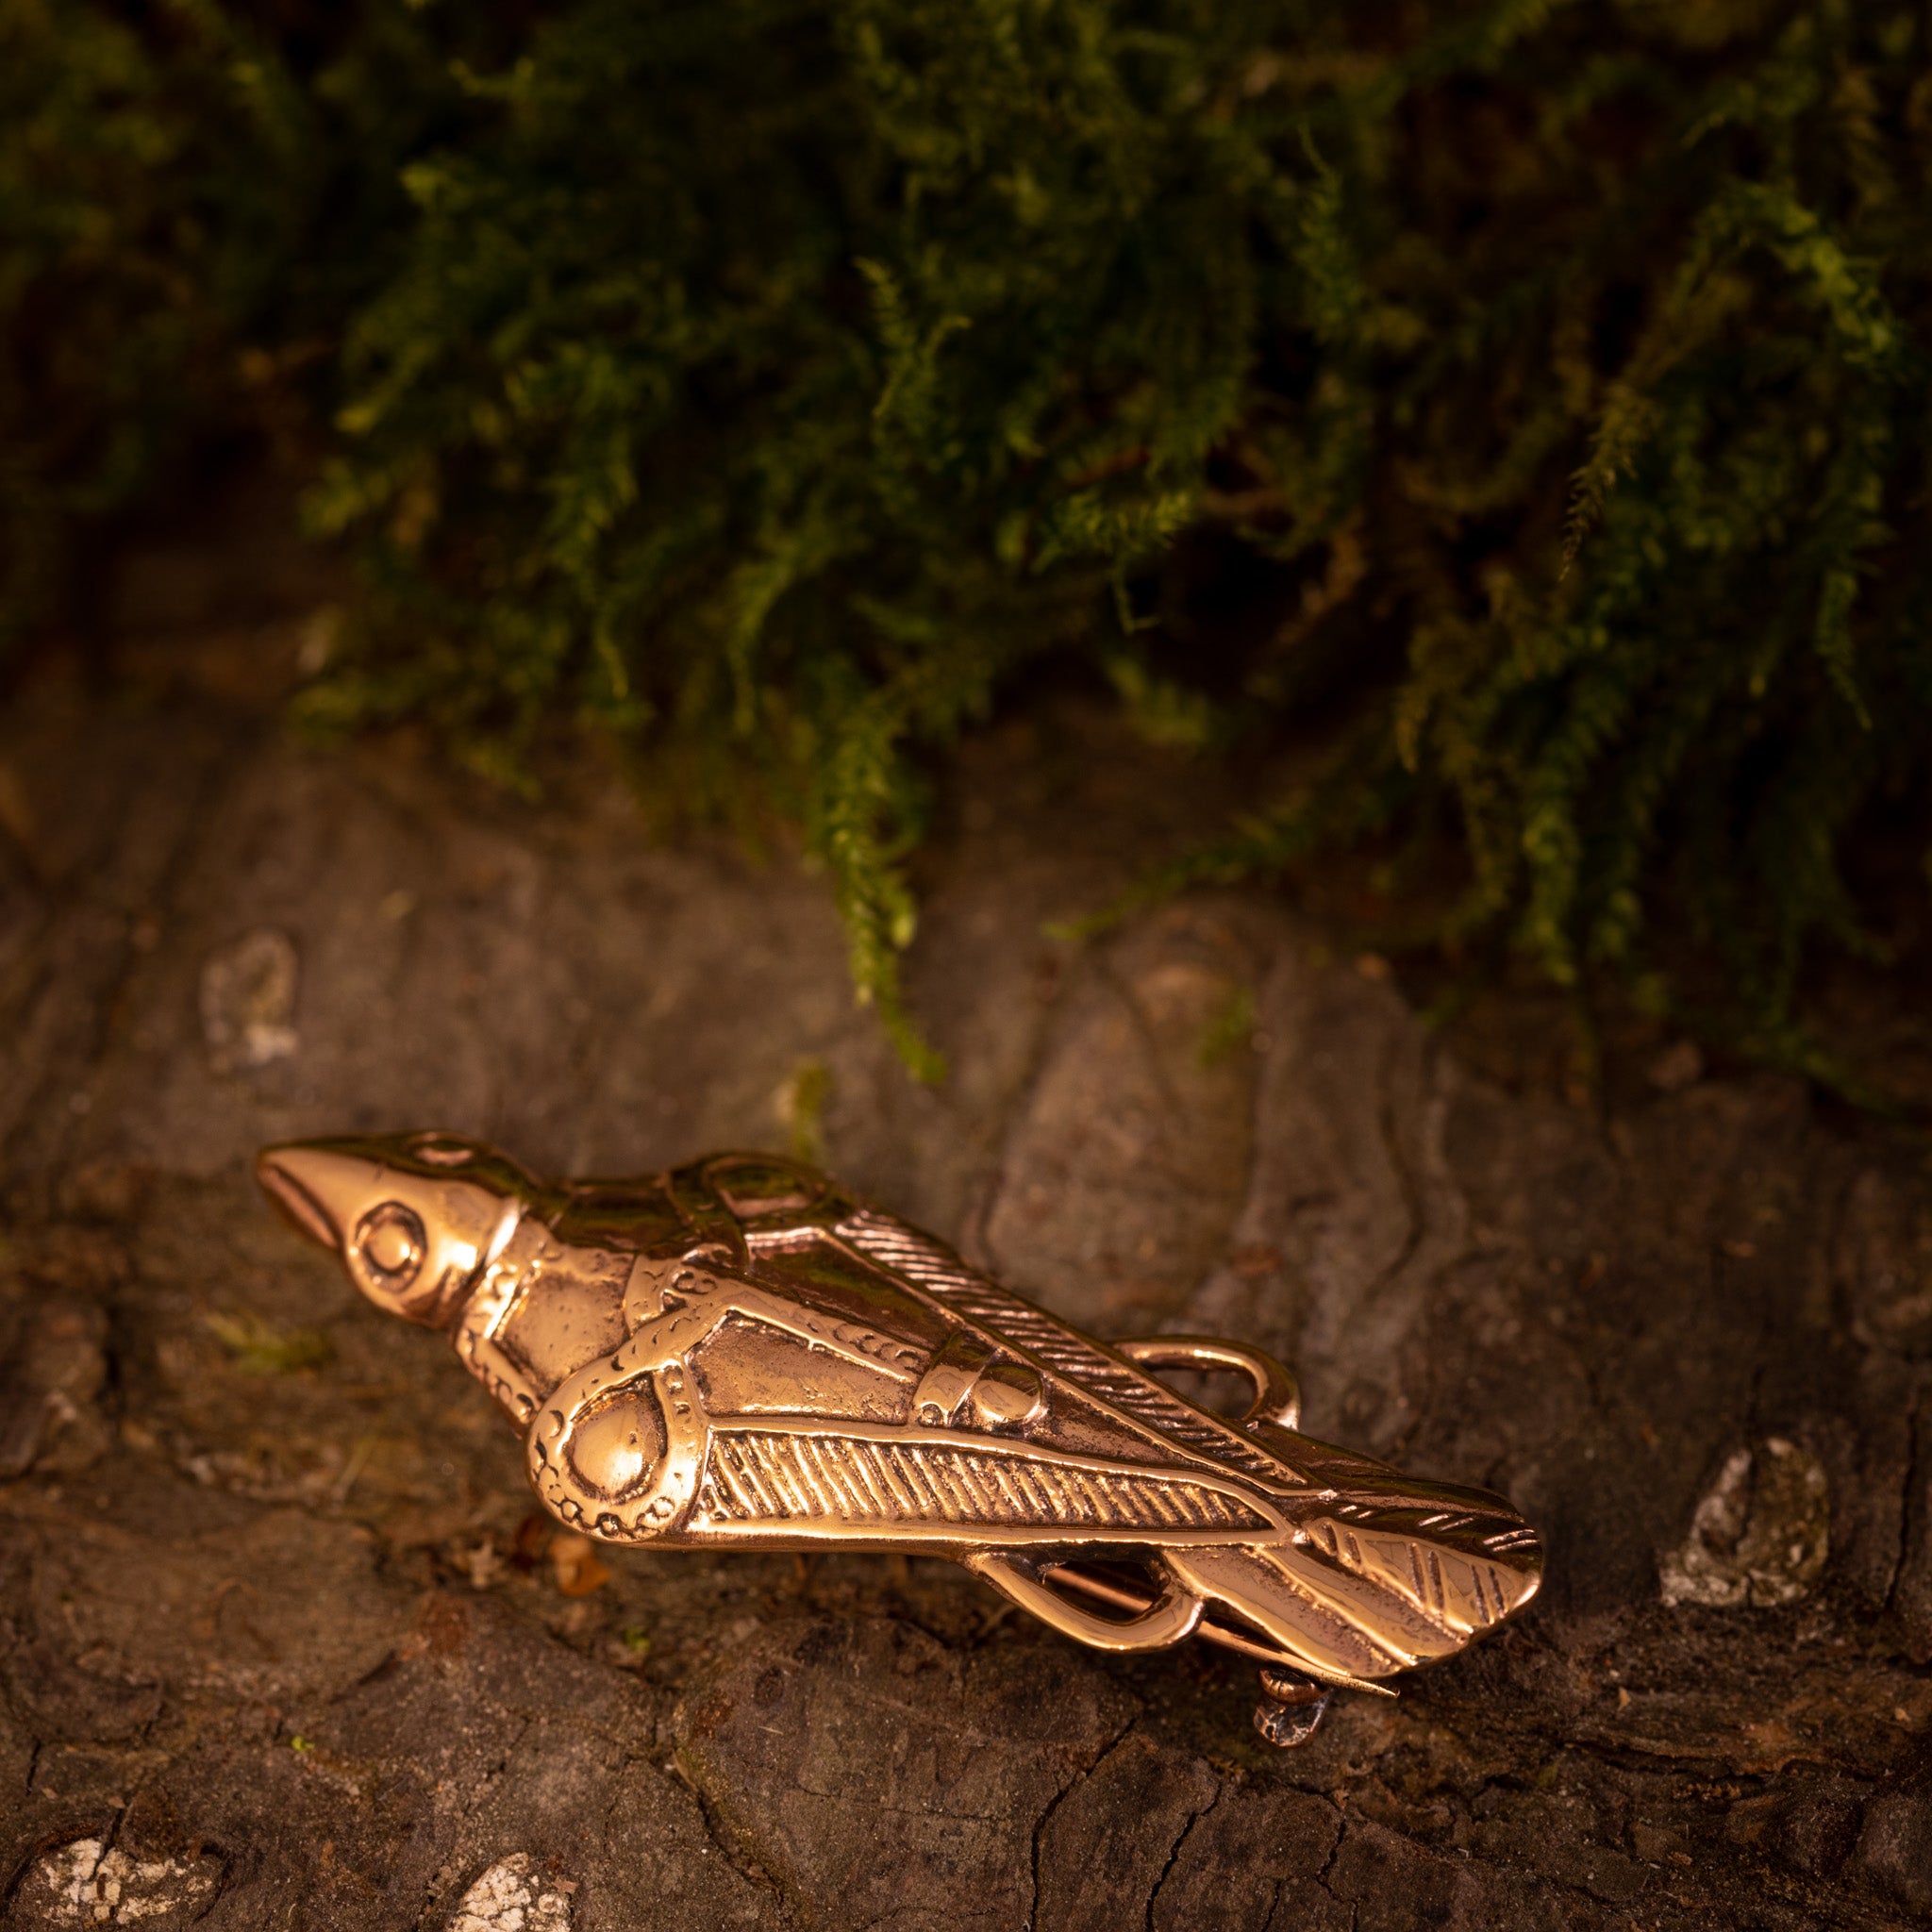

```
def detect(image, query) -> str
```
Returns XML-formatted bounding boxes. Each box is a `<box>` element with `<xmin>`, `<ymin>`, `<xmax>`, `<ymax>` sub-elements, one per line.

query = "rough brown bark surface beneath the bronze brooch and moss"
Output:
<box><xmin>0</xmin><ymin>537</ymin><xmax>1932</xmax><ymax>1932</ymax></box>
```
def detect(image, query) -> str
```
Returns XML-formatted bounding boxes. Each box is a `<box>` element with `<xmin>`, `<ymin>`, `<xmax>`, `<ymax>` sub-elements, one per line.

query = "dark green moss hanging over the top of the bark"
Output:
<box><xmin>0</xmin><ymin>0</ymin><xmax>1932</xmax><ymax>1071</ymax></box>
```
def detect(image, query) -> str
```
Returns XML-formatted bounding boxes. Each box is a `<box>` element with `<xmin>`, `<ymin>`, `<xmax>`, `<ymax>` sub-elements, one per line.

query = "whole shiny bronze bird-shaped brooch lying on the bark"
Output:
<box><xmin>258</xmin><ymin>1134</ymin><xmax>1541</xmax><ymax>1742</ymax></box>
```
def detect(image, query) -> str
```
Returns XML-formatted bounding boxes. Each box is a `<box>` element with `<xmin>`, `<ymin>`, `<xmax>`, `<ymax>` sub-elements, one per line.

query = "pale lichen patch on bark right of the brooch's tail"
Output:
<box><xmin>1659</xmin><ymin>1436</ymin><xmax>1832</xmax><ymax>1609</ymax></box>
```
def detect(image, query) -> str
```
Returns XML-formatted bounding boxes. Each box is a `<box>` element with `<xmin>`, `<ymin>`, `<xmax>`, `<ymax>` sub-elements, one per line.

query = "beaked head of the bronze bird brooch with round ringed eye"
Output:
<box><xmin>255</xmin><ymin>1132</ymin><xmax>541</xmax><ymax>1327</ymax></box>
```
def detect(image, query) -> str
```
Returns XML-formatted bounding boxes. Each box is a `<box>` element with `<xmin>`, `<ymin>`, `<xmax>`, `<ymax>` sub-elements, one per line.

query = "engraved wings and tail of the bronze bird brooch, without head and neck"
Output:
<box><xmin>529</xmin><ymin>1159</ymin><xmax>1541</xmax><ymax>1683</ymax></box>
